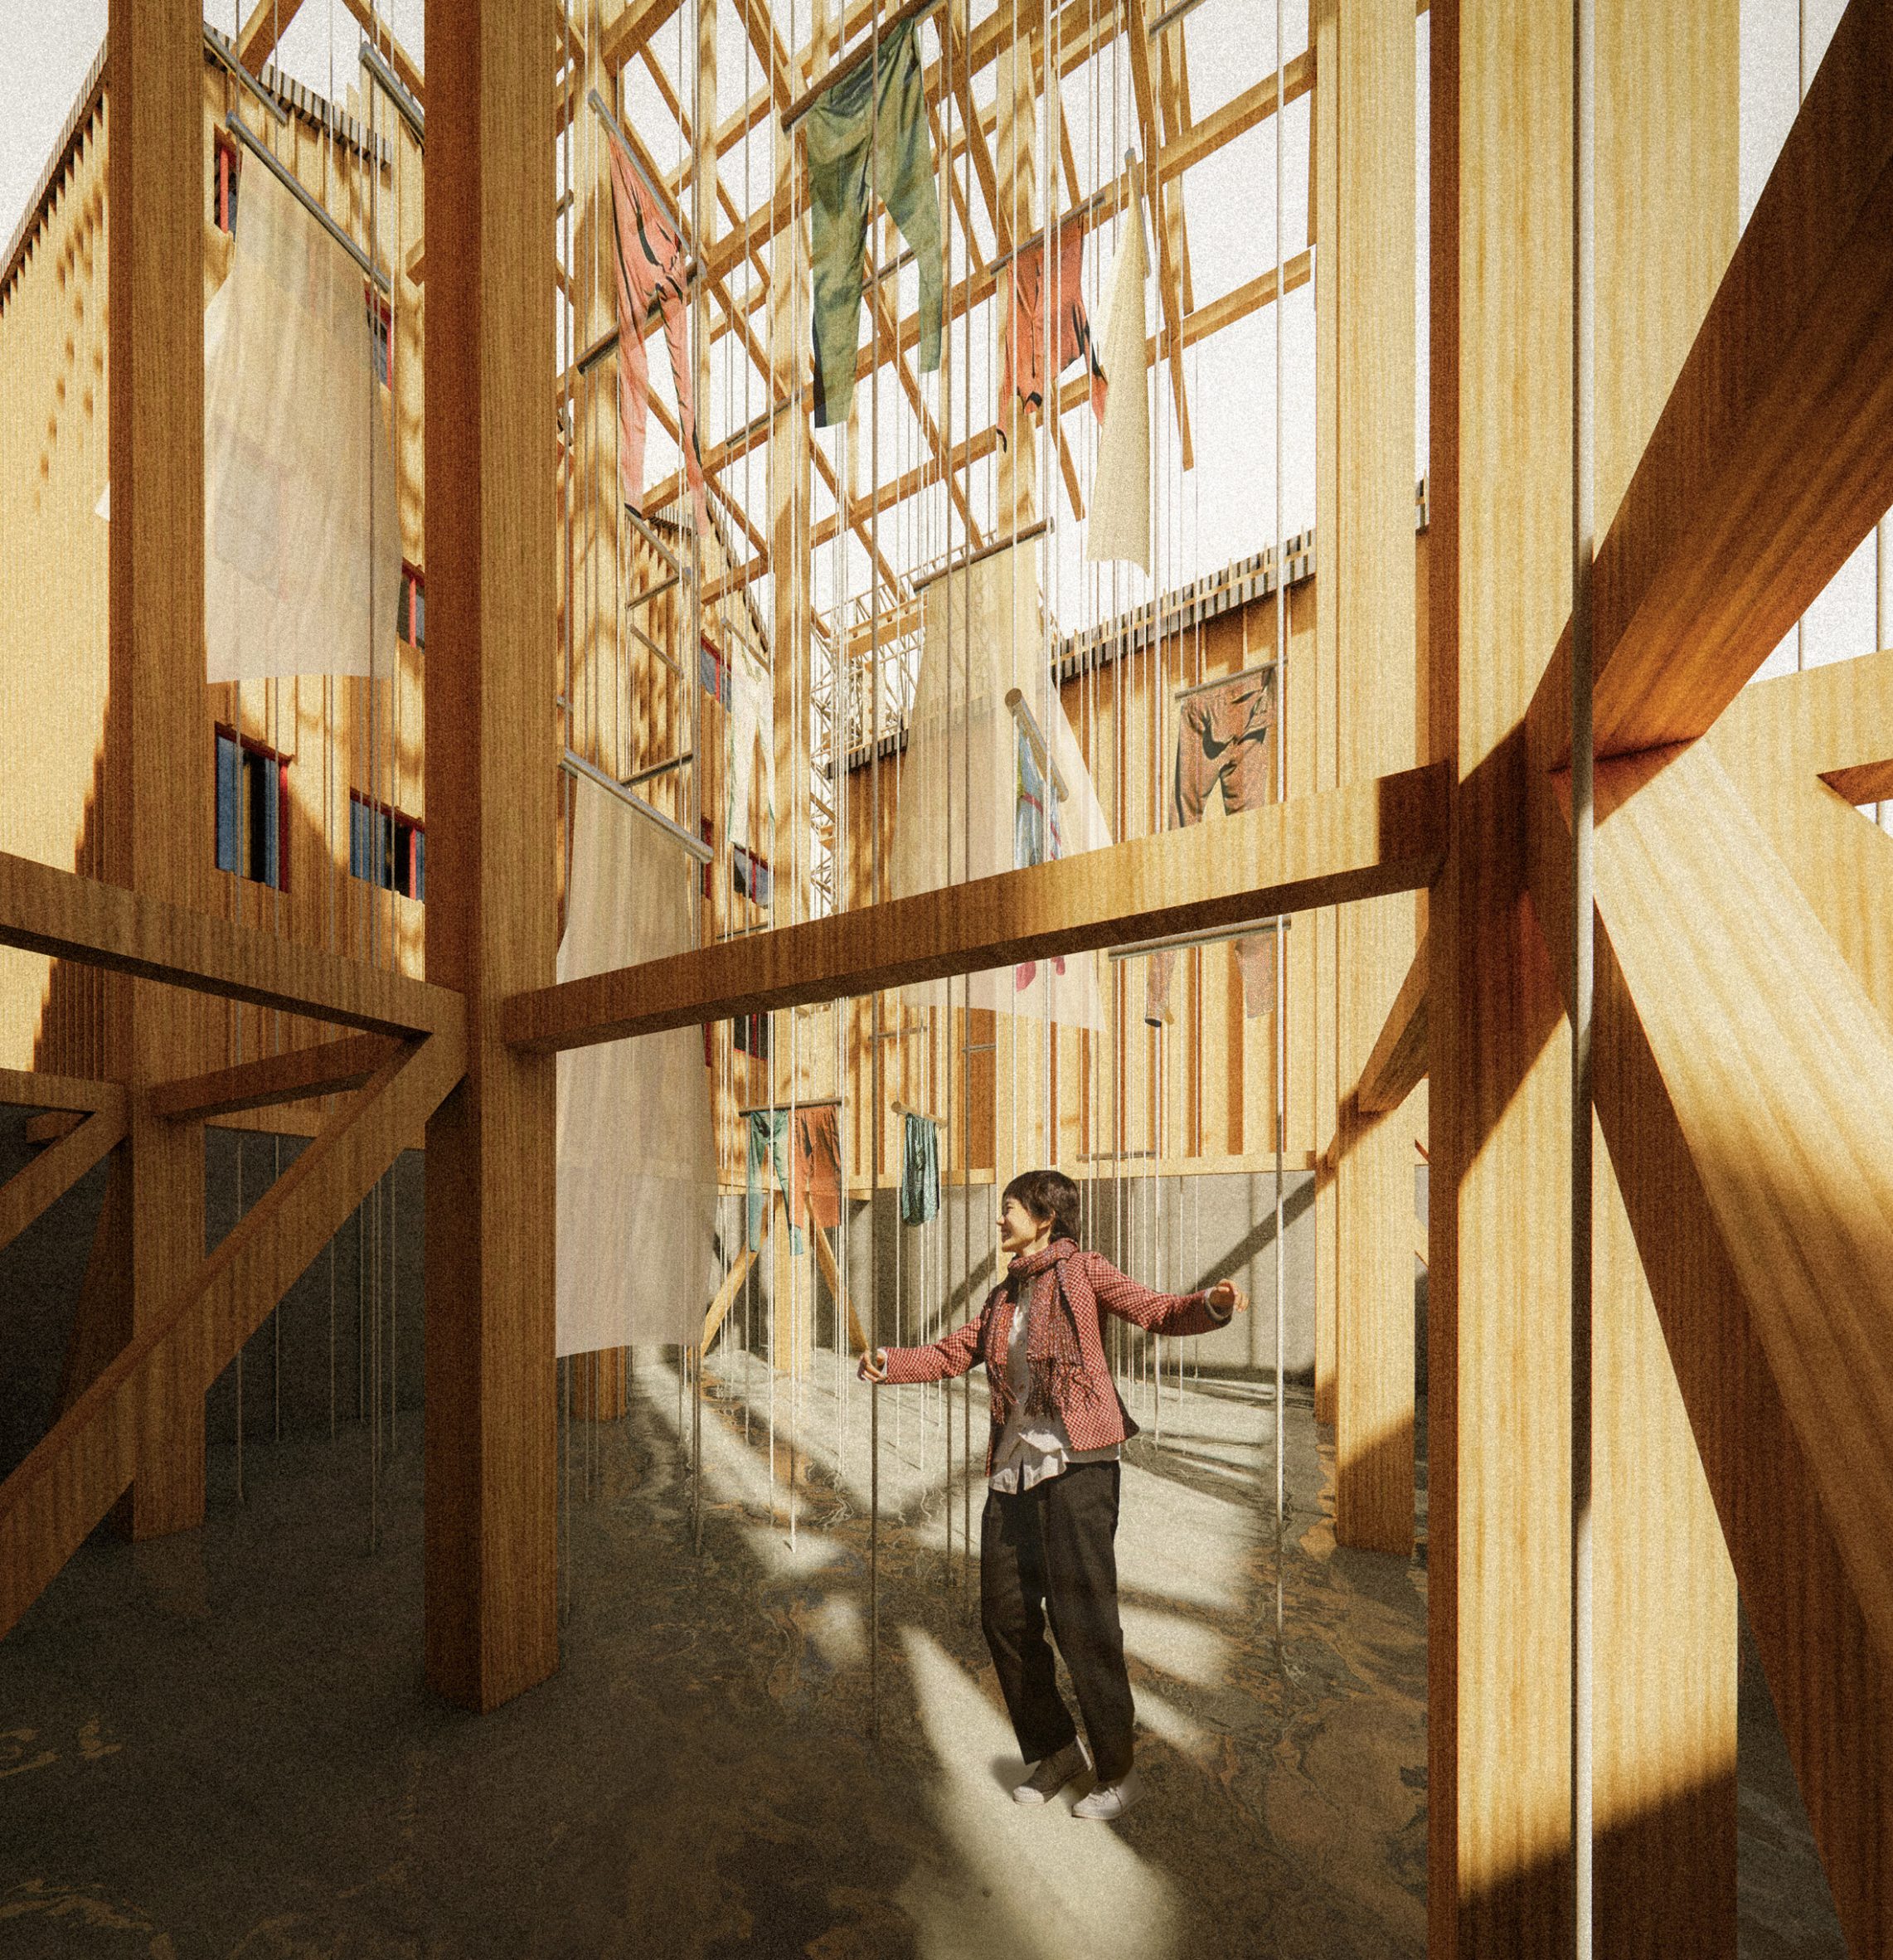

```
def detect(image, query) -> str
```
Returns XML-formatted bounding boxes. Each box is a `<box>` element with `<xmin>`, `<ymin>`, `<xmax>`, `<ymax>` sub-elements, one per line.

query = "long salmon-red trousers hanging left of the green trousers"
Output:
<box><xmin>605</xmin><ymin>131</ymin><xmax>710</xmax><ymax>537</ymax></box>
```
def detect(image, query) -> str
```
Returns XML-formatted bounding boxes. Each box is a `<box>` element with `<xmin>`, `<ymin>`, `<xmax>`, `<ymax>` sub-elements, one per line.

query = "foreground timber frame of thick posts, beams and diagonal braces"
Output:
<box><xmin>0</xmin><ymin>0</ymin><xmax>1893</xmax><ymax>1960</ymax></box>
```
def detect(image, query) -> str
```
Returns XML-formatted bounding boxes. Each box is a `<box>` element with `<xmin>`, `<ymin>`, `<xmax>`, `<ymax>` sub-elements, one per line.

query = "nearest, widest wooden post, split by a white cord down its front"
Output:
<box><xmin>1429</xmin><ymin>0</ymin><xmax>1735</xmax><ymax>1960</ymax></box>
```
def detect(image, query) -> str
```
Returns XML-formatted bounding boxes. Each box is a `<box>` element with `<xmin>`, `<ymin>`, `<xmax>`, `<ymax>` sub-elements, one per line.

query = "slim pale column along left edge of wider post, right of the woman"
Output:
<box><xmin>1305</xmin><ymin>0</ymin><xmax>1341</xmax><ymax>1423</ymax></box>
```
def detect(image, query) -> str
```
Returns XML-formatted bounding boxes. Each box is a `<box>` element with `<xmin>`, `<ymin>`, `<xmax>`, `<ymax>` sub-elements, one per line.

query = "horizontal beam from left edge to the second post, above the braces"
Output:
<box><xmin>0</xmin><ymin>852</ymin><xmax>463</xmax><ymax>1035</ymax></box>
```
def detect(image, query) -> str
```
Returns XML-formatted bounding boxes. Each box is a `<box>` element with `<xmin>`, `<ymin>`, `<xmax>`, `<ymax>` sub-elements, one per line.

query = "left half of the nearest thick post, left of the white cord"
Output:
<box><xmin>1427</xmin><ymin>0</ymin><xmax>1571</xmax><ymax>1936</ymax></box>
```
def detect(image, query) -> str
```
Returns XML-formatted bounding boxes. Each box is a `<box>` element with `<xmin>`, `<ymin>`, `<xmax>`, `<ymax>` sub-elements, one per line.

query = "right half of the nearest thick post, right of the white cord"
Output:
<box><xmin>1593</xmin><ymin>0</ymin><xmax>1738</xmax><ymax>1960</ymax></box>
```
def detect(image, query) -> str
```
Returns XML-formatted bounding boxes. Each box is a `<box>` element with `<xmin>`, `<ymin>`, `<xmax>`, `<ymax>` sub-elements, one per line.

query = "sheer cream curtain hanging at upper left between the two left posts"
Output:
<box><xmin>204</xmin><ymin>158</ymin><xmax>401</xmax><ymax>680</ymax></box>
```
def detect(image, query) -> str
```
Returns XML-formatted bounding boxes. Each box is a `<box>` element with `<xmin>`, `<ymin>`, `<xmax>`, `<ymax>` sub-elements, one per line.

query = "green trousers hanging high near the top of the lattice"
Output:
<box><xmin>805</xmin><ymin>20</ymin><xmax>943</xmax><ymax>429</ymax></box>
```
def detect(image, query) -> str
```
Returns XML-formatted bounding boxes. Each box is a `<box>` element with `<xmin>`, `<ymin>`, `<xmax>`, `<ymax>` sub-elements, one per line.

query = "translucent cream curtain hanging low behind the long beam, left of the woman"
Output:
<box><xmin>559</xmin><ymin>779</ymin><xmax>717</xmax><ymax>1355</ymax></box>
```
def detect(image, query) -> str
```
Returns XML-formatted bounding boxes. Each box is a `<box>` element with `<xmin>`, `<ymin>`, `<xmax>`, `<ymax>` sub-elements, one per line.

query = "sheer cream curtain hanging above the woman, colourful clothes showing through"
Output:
<box><xmin>890</xmin><ymin>541</ymin><xmax>1111</xmax><ymax>1027</ymax></box>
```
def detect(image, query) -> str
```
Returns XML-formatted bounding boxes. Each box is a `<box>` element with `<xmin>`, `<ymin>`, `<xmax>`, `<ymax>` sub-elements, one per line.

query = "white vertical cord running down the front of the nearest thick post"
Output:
<box><xmin>1571</xmin><ymin>0</ymin><xmax>1597</xmax><ymax>1960</ymax></box>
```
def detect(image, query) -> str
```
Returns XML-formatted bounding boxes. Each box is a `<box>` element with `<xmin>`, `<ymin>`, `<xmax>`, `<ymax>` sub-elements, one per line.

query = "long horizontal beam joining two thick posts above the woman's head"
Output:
<box><xmin>500</xmin><ymin>766</ymin><xmax>1446</xmax><ymax>1049</ymax></box>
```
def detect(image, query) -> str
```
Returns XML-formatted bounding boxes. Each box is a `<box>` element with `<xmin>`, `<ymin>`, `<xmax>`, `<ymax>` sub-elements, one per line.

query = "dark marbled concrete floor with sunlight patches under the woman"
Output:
<box><xmin>0</xmin><ymin>1355</ymin><xmax>1842</xmax><ymax>1960</ymax></box>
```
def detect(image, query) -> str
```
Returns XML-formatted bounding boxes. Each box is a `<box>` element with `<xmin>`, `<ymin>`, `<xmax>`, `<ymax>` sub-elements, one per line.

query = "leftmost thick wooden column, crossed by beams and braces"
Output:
<box><xmin>104</xmin><ymin>0</ymin><xmax>216</xmax><ymax>1539</ymax></box>
